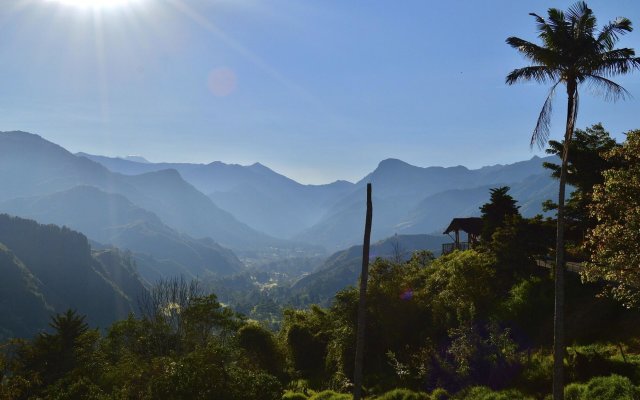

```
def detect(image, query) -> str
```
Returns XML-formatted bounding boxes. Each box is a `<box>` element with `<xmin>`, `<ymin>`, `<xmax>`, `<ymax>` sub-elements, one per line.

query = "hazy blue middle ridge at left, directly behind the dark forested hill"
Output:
<box><xmin>0</xmin><ymin>185</ymin><xmax>244</xmax><ymax>282</ymax></box>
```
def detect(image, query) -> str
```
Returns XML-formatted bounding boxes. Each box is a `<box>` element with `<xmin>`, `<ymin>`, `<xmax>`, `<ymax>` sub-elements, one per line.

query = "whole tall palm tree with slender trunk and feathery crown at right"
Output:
<box><xmin>506</xmin><ymin>2</ymin><xmax>640</xmax><ymax>400</ymax></box>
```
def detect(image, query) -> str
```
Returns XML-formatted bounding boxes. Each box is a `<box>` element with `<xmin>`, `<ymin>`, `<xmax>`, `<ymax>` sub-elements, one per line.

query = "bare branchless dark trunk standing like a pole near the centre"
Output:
<box><xmin>353</xmin><ymin>183</ymin><xmax>373</xmax><ymax>400</ymax></box>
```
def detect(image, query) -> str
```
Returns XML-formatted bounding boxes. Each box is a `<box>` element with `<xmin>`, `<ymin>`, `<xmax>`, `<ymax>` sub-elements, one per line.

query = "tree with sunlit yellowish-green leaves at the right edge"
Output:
<box><xmin>583</xmin><ymin>130</ymin><xmax>640</xmax><ymax>307</ymax></box>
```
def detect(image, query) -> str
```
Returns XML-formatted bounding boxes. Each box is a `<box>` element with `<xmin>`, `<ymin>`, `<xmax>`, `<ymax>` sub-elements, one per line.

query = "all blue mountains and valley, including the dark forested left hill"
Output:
<box><xmin>0</xmin><ymin>131</ymin><xmax>557</xmax><ymax>337</ymax></box>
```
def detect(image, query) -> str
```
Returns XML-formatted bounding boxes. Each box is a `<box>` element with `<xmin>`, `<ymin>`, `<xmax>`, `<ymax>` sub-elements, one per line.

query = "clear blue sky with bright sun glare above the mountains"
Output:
<box><xmin>0</xmin><ymin>0</ymin><xmax>640</xmax><ymax>184</ymax></box>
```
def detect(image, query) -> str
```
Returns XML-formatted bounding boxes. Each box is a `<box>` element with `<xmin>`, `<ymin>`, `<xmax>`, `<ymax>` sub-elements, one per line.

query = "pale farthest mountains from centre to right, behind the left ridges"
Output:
<box><xmin>78</xmin><ymin>148</ymin><xmax>557</xmax><ymax>251</ymax></box>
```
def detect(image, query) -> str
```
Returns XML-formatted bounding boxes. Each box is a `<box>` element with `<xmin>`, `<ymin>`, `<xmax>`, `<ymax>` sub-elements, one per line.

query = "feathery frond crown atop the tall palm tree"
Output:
<box><xmin>506</xmin><ymin>1</ymin><xmax>640</xmax><ymax>148</ymax></box>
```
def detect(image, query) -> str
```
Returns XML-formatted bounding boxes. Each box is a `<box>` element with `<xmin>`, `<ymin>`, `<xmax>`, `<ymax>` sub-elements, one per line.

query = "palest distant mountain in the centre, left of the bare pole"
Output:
<box><xmin>76</xmin><ymin>153</ymin><xmax>354</xmax><ymax>238</ymax></box>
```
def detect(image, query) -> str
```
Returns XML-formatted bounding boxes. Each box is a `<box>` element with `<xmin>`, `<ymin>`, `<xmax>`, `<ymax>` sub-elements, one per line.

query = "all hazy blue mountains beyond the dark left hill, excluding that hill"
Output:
<box><xmin>0</xmin><ymin>131</ymin><xmax>557</xmax><ymax>282</ymax></box>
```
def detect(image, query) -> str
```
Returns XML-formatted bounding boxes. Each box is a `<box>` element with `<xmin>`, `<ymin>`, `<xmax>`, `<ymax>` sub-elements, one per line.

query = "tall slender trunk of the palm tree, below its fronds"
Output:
<box><xmin>553</xmin><ymin>81</ymin><xmax>577</xmax><ymax>400</ymax></box>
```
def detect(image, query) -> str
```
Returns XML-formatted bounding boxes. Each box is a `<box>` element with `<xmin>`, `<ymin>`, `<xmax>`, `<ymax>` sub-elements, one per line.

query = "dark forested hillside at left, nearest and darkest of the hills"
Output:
<box><xmin>0</xmin><ymin>214</ymin><xmax>146</xmax><ymax>339</ymax></box>
